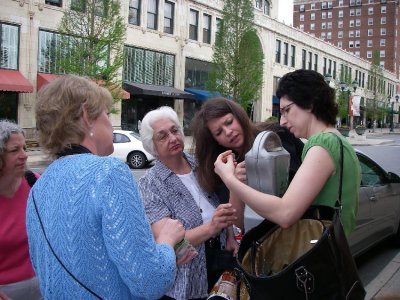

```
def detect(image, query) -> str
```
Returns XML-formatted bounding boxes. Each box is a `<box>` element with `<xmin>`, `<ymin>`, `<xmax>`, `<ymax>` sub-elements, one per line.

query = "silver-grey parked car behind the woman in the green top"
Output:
<box><xmin>244</xmin><ymin>149</ymin><xmax>400</xmax><ymax>256</ymax></box>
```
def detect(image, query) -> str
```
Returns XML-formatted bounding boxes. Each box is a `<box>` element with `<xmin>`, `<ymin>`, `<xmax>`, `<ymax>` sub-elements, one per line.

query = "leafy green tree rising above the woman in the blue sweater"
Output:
<box><xmin>57</xmin><ymin>0</ymin><xmax>126</xmax><ymax>101</ymax></box>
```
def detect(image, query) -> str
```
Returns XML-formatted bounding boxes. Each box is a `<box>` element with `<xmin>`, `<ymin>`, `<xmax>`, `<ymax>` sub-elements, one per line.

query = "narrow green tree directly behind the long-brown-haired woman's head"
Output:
<box><xmin>207</xmin><ymin>0</ymin><xmax>264</xmax><ymax>111</ymax></box>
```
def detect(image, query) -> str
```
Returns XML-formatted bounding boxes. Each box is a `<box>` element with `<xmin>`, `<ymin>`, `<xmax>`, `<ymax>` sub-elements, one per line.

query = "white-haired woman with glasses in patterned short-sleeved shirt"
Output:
<box><xmin>139</xmin><ymin>106</ymin><xmax>237</xmax><ymax>299</ymax></box>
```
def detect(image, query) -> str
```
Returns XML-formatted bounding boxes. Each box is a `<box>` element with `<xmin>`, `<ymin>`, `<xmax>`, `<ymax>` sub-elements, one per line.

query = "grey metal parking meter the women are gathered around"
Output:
<box><xmin>244</xmin><ymin>131</ymin><xmax>290</xmax><ymax>231</ymax></box>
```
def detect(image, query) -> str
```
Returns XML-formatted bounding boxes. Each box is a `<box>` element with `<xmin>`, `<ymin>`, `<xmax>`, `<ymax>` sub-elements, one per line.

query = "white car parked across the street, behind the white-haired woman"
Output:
<box><xmin>111</xmin><ymin>130</ymin><xmax>154</xmax><ymax>169</ymax></box>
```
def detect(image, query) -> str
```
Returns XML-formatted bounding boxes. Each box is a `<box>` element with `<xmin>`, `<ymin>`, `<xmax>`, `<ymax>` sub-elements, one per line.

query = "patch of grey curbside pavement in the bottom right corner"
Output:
<box><xmin>365</xmin><ymin>253</ymin><xmax>400</xmax><ymax>300</ymax></box>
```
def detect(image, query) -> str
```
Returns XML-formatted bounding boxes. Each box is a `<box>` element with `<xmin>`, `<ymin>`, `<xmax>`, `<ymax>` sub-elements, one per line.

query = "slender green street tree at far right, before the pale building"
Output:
<box><xmin>368</xmin><ymin>51</ymin><xmax>383</xmax><ymax>130</ymax></box>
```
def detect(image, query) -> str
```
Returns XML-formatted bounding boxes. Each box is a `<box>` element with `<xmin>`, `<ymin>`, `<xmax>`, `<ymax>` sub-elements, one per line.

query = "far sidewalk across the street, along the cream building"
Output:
<box><xmin>27</xmin><ymin>128</ymin><xmax>400</xmax><ymax>167</ymax></box>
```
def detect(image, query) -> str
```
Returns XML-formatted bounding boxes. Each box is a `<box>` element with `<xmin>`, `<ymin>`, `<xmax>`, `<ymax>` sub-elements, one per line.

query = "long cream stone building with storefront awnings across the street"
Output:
<box><xmin>0</xmin><ymin>0</ymin><xmax>399</xmax><ymax>138</ymax></box>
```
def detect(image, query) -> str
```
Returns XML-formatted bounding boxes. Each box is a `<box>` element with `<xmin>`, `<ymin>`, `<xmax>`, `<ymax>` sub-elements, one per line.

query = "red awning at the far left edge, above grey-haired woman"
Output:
<box><xmin>0</xmin><ymin>70</ymin><xmax>33</xmax><ymax>93</ymax></box>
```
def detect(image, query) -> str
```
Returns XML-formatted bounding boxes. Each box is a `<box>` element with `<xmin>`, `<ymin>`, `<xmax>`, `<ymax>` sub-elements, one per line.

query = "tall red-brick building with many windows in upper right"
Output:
<box><xmin>293</xmin><ymin>0</ymin><xmax>400</xmax><ymax>77</ymax></box>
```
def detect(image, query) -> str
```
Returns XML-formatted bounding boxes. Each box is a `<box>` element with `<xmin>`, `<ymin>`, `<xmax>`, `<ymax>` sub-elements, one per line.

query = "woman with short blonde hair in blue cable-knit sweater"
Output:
<box><xmin>27</xmin><ymin>75</ymin><xmax>185</xmax><ymax>300</ymax></box>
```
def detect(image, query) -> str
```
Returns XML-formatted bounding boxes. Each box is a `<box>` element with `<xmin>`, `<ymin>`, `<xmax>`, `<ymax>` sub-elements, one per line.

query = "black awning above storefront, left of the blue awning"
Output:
<box><xmin>123</xmin><ymin>82</ymin><xmax>195</xmax><ymax>100</ymax></box>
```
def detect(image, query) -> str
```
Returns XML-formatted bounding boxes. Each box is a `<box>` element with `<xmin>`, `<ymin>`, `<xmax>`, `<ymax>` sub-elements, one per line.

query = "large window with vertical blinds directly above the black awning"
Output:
<box><xmin>123</xmin><ymin>46</ymin><xmax>175</xmax><ymax>86</ymax></box>
